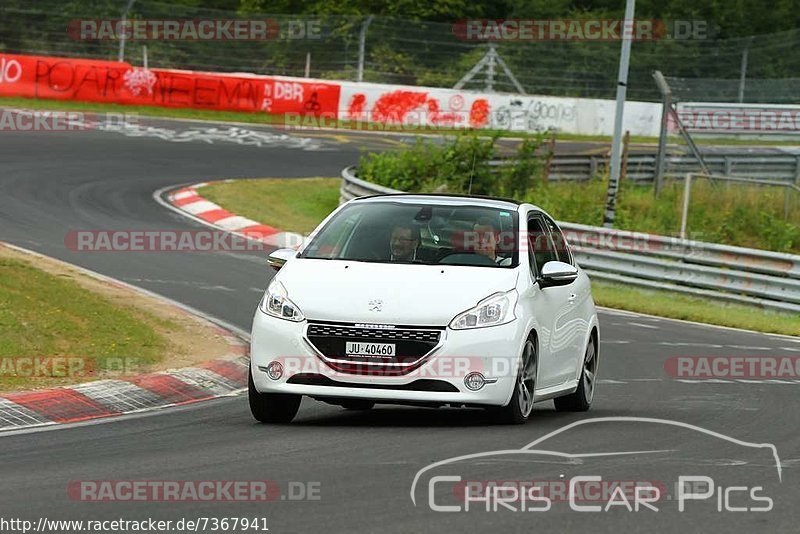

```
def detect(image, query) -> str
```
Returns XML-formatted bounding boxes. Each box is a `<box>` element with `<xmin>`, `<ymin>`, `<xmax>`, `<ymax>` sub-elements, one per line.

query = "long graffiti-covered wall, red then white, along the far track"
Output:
<box><xmin>0</xmin><ymin>54</ymin><xmax>661</xmax><ymax>136</ymax></box>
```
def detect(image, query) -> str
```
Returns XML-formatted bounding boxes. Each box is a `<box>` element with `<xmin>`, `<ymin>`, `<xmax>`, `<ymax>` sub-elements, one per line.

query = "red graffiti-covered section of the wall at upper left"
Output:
<box><xmin>0</xmin><ymin>54</ymin><xmax>339</xmax><ymax>117</ymax></box>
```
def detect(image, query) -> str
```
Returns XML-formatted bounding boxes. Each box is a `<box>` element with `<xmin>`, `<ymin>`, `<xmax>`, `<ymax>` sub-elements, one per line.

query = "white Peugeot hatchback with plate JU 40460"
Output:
<box><xmin>249</xmin><ymin>194</ymin><xmax>599</xmax><ymax>423</ymax></box>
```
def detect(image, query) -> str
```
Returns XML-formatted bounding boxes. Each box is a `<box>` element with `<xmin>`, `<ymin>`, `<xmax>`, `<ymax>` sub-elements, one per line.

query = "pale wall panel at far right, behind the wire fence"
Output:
<box><xmin>669</xmin><ymin>102</ymin><xmax>800</xmax><ymax>135</ymax></box>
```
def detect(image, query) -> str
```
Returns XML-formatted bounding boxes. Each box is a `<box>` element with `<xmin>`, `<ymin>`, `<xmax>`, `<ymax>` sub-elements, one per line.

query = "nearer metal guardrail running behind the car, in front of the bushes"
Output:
<box><xmin>340</xmin><ymin>167</ymin><xmax>800</xmax><ymax>313</ymax></box>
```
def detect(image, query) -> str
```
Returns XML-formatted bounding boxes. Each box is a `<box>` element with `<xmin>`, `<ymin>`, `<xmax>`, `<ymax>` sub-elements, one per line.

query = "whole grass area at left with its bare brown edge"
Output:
<box><xmin>0</xmin><ymin>243</ymin><xmax>229</xmax><ymax>391</ymax></box>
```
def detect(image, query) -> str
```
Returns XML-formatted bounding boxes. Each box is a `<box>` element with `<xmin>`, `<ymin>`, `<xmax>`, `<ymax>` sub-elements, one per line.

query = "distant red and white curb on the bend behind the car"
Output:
<box><xmin>167</xmin><ymin>182</ymin><xmax>305</xmax><ymax>248</ymax></box>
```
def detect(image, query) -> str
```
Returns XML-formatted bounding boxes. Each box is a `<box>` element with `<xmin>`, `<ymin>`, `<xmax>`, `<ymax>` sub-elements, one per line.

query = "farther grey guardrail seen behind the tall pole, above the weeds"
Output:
<box><xmin>491</xmin><ymin>154</ymin><xmax>800</xmax><ymax>184</ymax></box>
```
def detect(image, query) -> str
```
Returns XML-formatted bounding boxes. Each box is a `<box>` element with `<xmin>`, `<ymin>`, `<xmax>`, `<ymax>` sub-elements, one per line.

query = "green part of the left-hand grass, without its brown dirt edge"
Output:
<box><xmin>0</xmin><ymin>258</ymin><xmax>167</xmax><ymax>389</ymax></box>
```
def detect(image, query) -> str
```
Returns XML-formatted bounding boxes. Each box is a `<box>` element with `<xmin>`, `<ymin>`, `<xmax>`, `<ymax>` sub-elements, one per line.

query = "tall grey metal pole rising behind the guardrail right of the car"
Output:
<box><xmin>603</xmin><ymin>0</ymin><xmax>636</xmax><ymax>228</ymax></box>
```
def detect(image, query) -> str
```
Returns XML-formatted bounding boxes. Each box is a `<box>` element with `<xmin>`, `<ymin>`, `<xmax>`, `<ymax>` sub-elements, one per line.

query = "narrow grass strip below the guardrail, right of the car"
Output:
<box><xmin>592</xmin><ymin>281</ymin><xmax>800</xmax><ymax>336</ymax></box>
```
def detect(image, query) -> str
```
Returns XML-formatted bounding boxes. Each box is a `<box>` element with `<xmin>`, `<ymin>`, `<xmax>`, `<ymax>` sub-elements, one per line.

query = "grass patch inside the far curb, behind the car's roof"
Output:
<box><xmin>201</xmin><ymin>178</ymin><xmax>341</xmax><ymax>234</ymax></box>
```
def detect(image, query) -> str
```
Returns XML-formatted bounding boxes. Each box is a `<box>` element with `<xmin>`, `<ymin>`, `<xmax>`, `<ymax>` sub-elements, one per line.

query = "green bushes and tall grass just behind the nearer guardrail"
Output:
<box><xmin>359</xmin><ymin>133</ymin><xmax>800</xmax><ymax>253</ymax></box>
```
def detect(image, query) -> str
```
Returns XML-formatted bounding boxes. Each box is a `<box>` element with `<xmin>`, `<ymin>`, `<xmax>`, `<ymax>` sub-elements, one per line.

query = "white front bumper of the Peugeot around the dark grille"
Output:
<box><xmin>250</xmin><ymin>311</ymin><xmax>527</xmax><ymax>406</ymax></box>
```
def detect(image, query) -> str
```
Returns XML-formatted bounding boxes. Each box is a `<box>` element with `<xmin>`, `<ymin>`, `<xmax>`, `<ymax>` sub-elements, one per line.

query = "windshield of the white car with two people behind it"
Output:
<box><xmin>301</xmin><ymin>201</ymin><xmax>518</xmax><ymax>268</ymax></box>
